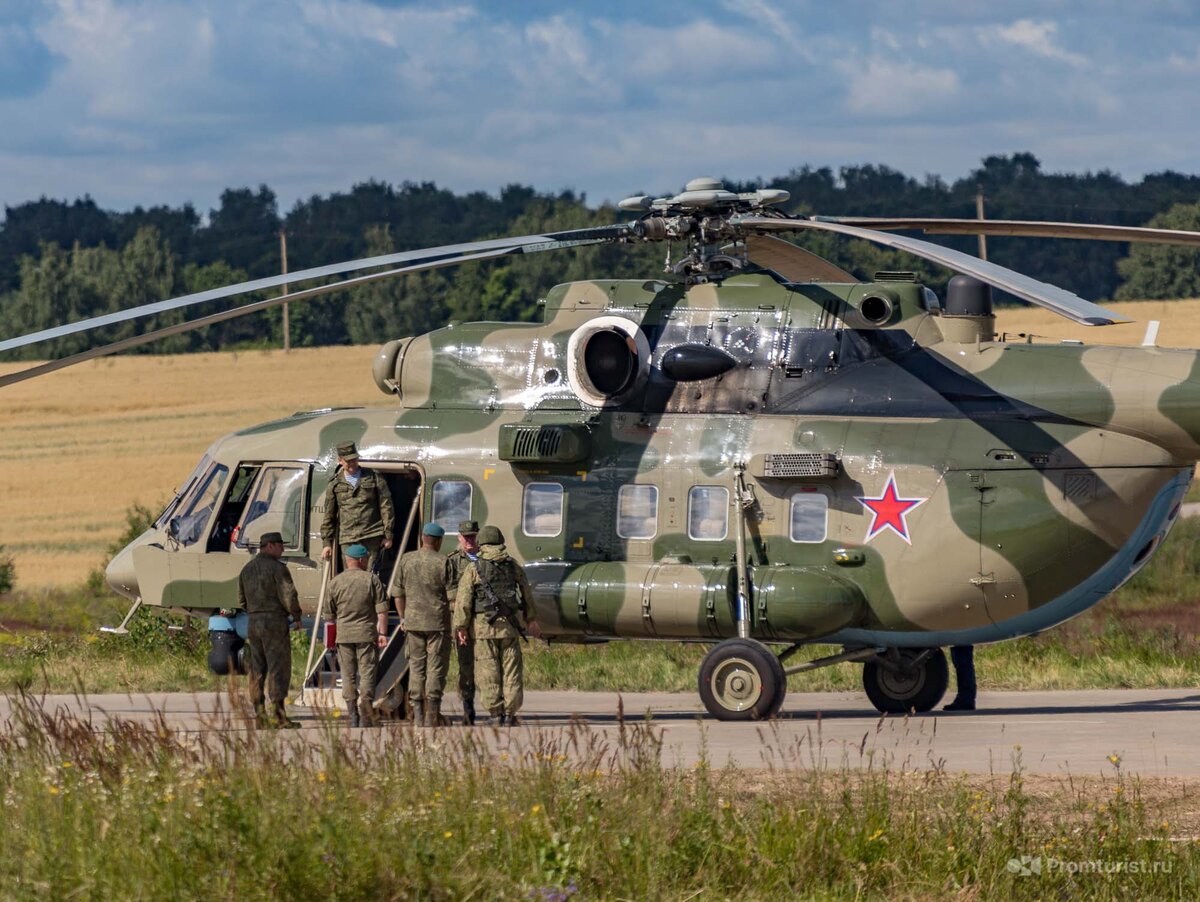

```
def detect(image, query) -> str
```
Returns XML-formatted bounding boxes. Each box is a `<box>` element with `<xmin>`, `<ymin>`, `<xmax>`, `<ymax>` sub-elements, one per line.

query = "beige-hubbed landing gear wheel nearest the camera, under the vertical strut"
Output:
<box><xmin>698</xmin><ymin>639</ymin><xmax>786</xmax><ymax>721</ymax></box>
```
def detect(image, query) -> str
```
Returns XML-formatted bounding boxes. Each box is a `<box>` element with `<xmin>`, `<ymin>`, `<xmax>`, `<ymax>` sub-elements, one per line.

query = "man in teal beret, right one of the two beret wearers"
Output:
<box><xmin>390</xmin><ymin>523</ymin><xmax>450</xmax><ymax>727</ymax></box>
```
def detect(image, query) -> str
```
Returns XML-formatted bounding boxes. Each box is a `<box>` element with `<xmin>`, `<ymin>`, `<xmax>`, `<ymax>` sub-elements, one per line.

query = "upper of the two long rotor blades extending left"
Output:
<box><xmin>0</xmin><ymin>224</ymin><xmax>629</xmax><ymax>351</ymax></box>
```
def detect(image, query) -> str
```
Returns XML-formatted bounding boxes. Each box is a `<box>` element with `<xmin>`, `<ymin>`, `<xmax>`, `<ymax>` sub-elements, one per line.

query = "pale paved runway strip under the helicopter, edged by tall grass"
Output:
<box><xmin>0</xmin><ymin>688</ymin><xmax>1200</xmax><ymax>777</ymax></box>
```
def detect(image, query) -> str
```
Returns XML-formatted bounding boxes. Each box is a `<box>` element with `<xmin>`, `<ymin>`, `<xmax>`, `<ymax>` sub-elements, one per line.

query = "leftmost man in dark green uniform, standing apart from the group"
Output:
<box><xmin>238</xmin><ymin>533</ymin><xmax>300</xmax><ymax>728</ymax></box>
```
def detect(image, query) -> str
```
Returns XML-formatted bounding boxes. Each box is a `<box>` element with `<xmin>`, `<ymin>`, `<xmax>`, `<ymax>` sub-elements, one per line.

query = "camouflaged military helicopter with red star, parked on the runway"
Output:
<box><xmin>0</xmin><ymin>173</ymin><xmax>1200</xmax><ymax>721</ymax></box>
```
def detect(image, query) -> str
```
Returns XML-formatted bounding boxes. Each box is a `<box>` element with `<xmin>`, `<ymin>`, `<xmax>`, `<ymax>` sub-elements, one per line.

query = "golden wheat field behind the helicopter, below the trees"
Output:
<box><xmin>0</xmin><ymin>301</ymin><xmax>1200</xmax><ymax>588</ymax></box>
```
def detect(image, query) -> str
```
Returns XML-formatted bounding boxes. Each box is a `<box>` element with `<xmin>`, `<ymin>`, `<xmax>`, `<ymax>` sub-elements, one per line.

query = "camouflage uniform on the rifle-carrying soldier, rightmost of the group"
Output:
<box><xmin>454</xmin><ymin>545</ymin><xmax>533</xmax><ymax>717</ymax></box>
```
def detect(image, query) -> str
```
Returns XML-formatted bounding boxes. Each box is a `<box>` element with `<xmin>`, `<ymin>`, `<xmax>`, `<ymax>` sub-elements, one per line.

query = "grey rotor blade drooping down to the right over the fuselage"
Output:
<box><xmin>730</xmin><ymin>216</ymin><xmax>1129</xmax><ymax>326</ymax></box>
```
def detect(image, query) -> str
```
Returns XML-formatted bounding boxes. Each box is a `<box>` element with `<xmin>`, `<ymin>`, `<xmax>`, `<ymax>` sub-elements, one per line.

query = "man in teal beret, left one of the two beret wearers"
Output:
<box><xmin>329</xmin><ymin>543</ymin><xmax>388</xmax><ymax>727</ymax></box>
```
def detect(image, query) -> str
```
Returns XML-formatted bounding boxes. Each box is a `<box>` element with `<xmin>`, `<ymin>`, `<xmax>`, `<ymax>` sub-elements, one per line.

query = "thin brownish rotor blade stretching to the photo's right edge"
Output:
<box><xmin>816</xmin><ymin>216</ymin><xmax>1200</xmax><ymax>247</ymax></box>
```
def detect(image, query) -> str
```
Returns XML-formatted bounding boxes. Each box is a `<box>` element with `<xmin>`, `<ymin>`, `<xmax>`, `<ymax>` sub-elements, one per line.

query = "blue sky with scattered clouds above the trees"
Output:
<box><xmin>0</xmin><ymin>0</ymin><xmax>1200</xmax><ymax>211</ymax></box>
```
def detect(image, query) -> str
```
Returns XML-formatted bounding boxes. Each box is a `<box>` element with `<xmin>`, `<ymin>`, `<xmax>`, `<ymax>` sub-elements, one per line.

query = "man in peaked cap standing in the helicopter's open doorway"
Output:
<box><xmin>320</xmin><ymin>441</ymin><xmax>392</xmax><ymax>573</ymax></box>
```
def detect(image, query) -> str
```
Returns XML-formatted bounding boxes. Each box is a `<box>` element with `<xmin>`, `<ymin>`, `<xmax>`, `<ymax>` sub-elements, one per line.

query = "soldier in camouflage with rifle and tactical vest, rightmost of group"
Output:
<box><xmin>454</xmin><ymin>527</ymin><xmax>541</xmax><ymax>727</ymax></box>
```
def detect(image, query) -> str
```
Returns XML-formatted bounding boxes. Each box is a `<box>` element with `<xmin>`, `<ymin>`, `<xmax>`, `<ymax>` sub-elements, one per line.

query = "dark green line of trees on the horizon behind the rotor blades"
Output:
<box><xmin>0</xmin><ymin>154</ymin><xmax>1200</xmax><ymax>357</ymax></box>
